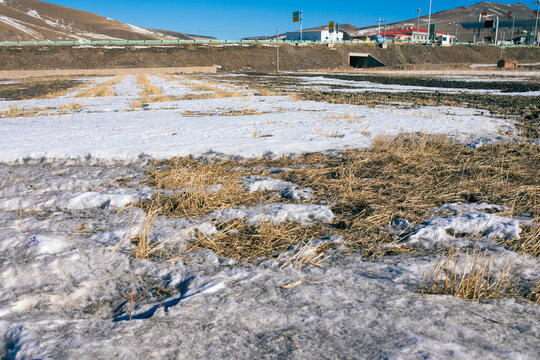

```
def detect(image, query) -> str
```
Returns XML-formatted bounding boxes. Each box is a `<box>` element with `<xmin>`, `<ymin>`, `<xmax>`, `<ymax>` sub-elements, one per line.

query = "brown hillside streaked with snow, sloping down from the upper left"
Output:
<box><xmin>0</xmin><ymin>0</ymin><xmax>215</xmax><ymax>41</ymax></box>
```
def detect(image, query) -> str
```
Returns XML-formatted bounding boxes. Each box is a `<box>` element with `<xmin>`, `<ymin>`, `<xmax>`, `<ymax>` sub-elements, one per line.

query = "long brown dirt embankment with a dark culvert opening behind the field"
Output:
<box><xmin>0</xmin><ymin>44</ymin><xmax>540</xmax><ymax>72</ymax></box>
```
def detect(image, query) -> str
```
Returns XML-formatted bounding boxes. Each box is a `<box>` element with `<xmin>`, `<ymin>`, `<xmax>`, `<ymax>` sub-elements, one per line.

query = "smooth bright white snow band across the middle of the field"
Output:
<box><xmin>0</xmin><ymin>76</ymin><xmax>513</xmax><ymax>162</ymax></box>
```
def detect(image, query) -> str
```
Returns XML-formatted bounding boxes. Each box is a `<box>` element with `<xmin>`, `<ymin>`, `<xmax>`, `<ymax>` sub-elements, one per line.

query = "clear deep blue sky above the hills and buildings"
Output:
<box><xmin>43</xmin><ymin>0</ymin><xmax>520</xmax><ymax>39</ymax></box>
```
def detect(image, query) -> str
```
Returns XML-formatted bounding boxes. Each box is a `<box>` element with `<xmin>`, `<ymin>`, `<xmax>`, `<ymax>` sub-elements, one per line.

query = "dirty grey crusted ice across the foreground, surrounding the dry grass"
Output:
<box><xmin>0</xmin><ymin>162</ymin><xmax>540</xmax><ymax>359</ymax></box>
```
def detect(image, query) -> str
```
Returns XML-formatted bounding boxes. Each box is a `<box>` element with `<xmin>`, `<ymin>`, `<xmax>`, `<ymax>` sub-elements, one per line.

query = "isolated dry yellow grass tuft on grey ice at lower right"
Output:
<box><xmin>421</xmin><ymin>247</ymin><xmax>532</xmax><ymax>301</ymax></box>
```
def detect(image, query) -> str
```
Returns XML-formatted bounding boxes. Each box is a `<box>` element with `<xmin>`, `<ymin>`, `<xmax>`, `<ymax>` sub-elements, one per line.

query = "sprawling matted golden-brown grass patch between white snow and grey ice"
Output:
<box><xmin>133</xmin><ymin>133</ymin><xmax>540</xmax><ymax>268</ymax></box>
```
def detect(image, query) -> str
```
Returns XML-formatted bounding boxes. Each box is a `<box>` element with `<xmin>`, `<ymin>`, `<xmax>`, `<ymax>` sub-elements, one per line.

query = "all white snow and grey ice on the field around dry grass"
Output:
<box><xmin>0</xmin><ymin>72</ymin><xmax>540</xmax><ymax>359</ymax></box>
